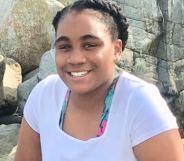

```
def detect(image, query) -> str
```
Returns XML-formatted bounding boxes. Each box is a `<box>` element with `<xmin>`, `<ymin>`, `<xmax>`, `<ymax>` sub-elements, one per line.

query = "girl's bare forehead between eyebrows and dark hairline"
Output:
<box><xmin>56</xmin><ymin>9</ymin><xmax>111</xmax><ymax>38</ymax></box>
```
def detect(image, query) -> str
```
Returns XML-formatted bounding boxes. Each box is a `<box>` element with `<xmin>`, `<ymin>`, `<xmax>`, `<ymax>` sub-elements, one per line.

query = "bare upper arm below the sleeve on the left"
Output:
<box><xmin>14</xmin><ymin>118</ymin><xmax>42</xmax><ymax>161</ymax></box>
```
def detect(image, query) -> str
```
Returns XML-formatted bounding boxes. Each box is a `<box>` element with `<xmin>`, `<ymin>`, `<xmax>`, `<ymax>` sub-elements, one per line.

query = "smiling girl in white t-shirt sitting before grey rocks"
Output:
<box><xmin>15</xmin><ymin>0</ymin><xmax>184</xmax><ymax>161</ymax></box>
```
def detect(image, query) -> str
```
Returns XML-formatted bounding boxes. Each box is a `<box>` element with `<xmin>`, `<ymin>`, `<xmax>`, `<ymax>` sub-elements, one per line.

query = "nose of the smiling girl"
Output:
<box><xmin>67</xmin><ymin>49</ymin><xmax>86</xmax><ymax>65</ymax></box>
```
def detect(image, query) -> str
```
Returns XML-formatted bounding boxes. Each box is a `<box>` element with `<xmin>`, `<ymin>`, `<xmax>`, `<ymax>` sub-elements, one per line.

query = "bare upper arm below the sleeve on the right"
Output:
<box><xmin>133</xmin><ymin>129</ymin><xmax>184</xmax><ymax>161</ymax></box>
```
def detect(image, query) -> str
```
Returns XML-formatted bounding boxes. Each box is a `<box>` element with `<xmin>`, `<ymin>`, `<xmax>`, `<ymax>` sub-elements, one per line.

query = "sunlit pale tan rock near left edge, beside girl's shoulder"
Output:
<box><xmin>3</xmin><ymin>58</ymin><xmax>22</xmax><ymax>107</ymax></box>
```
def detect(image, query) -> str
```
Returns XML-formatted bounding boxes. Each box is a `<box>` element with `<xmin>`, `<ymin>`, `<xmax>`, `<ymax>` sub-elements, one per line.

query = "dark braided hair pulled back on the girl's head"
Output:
<box><xmin>52</xmin><ymin>0</ymin><xmax>128</xmax><ymax>50</ymax></box>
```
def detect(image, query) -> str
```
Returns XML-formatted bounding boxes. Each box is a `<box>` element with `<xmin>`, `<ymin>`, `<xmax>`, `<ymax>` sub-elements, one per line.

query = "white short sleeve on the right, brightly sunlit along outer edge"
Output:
<box><xmin>129</xmin><ymin>85</ymin><xmax>178</xmax><ymax>146</ymax></box>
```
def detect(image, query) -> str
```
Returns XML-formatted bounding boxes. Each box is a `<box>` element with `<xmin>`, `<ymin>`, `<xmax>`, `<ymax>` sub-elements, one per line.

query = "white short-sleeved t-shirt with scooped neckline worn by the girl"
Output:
<box><xmin>24</xmin><ymin>72</ymin><xmax>177</xmax><ymax>161</ymax></box>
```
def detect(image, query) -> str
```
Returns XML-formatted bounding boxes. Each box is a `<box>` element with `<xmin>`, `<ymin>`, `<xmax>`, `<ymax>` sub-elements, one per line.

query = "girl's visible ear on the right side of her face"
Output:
<box><xmin>114</xmin><ymin>39</ymin><xmax>124</xmax><ymax>62</ymax></box>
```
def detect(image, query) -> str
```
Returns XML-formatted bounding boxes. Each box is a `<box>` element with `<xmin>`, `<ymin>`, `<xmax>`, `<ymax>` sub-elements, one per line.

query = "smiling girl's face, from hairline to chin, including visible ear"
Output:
<box><xmin>55</xmin><ymin>10</ymin><xmax>122</xmax><ymax>94</ymax></box>
